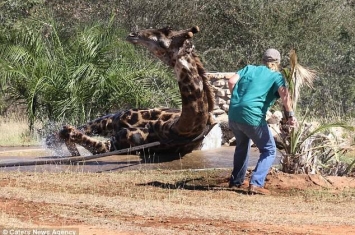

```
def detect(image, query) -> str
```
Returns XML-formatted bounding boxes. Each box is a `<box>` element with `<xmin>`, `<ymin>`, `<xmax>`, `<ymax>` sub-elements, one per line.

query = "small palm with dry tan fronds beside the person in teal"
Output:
<box><xmin>278</xmin><ymin>50</ymin><xmax>355</xmax><ymax>175</ymax></box>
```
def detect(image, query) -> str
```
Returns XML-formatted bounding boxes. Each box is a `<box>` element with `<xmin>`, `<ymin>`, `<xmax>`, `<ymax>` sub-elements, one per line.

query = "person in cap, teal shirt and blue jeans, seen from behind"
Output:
<box><xmin>228</xmin><ymin>48</ymin><xmax>297</xmax><ymax>194</ymax></box>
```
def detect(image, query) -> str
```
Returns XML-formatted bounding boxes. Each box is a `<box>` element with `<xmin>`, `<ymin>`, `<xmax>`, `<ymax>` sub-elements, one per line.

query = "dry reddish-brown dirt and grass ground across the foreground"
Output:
<box><xmin>0</xmin><ymin>169</ymin><xmax>355</xmax><ymax>235</ymax></box>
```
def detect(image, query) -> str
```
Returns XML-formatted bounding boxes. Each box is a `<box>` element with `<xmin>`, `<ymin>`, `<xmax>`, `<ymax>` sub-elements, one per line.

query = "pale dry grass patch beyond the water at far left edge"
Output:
<box><xmin>0</xmin><ymin>116</ymin><xmax>40</xmax><ymax>146</ymax></box>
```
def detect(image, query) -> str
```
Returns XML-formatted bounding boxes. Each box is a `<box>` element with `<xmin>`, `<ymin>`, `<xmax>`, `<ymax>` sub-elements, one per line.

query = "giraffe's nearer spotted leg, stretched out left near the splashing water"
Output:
<box><xmin>59</xmin><ymin>126</ymin><xmax>110</xmax><ymax>156</ymax></box>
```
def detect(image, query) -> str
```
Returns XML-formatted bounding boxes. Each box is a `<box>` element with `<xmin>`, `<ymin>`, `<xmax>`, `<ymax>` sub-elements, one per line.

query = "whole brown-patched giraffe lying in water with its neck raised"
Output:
<box><xmin>46</xmin><ymin>26</ymin><xmax>216</xmax><ymax>156</ymax></box>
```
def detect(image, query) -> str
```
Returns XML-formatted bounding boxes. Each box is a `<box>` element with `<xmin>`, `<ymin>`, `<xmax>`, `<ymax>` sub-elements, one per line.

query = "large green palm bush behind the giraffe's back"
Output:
<box><xmin>0</xmin><ymin>18</ymin><xmax>180</xmax><ymax>129</ymax></box>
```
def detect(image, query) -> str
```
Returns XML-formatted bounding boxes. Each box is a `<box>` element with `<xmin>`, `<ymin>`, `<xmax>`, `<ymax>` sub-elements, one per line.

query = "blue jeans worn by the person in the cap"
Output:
<box><xmin>229</xmin><ymin>120</ymin><xmax>276</xmax><ymax>187</ymax></box>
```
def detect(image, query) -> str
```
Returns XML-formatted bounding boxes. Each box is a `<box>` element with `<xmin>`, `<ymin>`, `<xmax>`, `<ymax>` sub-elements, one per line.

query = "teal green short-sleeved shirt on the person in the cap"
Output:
<box><xmin>228</xmin><ymin>65</ymin><xmax>286</xmax><ymax>126</ymax></box>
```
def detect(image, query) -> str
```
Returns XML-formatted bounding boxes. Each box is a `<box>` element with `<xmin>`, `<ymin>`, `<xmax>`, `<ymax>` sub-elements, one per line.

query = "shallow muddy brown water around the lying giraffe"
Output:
<box><xmin>0</xmin><ymin>146</ymin><xmax>279</xmax><ymax>172</ymax></box>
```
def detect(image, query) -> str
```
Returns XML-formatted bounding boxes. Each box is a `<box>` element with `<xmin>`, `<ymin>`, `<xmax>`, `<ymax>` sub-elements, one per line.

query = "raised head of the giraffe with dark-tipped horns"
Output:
<box><xmin>127</xmin><ymin>26</ymin><xmax>199</xmax><ymax>66</ymax></box>
